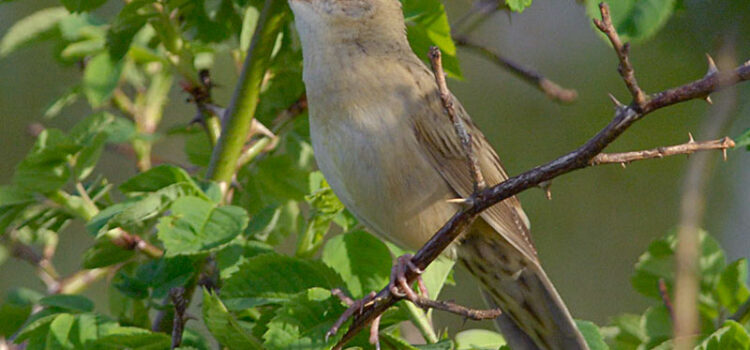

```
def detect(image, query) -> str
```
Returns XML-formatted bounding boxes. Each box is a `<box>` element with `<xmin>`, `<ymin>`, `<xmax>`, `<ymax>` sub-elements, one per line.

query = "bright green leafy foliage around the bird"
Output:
<box><xmin>0</xmin><ymin>0</ymin><xmax>750</xmax><ymax>349</ymax></box>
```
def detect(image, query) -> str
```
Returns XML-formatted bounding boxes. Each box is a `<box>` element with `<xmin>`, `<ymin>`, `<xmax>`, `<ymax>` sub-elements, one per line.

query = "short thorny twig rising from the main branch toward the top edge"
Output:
<box><xmin>594</xmin><ymin>2</ymin><xmax>646</xmax><ymax>108</ymax></box>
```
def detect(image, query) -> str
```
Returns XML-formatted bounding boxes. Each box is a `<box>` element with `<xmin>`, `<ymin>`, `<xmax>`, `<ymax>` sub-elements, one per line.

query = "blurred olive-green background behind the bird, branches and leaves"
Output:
<box><xmin>0</xmin><ymin>0</ymin><xmax>750</xmax><ymax>325</ymax></box>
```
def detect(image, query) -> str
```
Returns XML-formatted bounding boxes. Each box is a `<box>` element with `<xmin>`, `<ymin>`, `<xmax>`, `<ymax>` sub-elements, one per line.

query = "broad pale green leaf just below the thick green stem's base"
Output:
<box><xmin>156</xmin><ymin>196</ymin><xmax>249</xmax><ymax>256</ymax></box>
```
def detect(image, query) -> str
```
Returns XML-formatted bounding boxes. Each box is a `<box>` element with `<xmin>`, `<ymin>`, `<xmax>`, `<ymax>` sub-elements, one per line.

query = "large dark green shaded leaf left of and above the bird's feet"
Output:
<box><xmin>221</xmin><ymin>254</ymin><xmax>344</xmax><ymax>310</ymax></box>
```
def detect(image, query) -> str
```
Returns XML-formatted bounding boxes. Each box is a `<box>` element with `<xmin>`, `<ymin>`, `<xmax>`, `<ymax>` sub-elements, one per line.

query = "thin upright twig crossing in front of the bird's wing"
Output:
<box><xmin>429</xmin><ymin>46</ymin><xmax>487</xmax><ymax>194</ymax></box>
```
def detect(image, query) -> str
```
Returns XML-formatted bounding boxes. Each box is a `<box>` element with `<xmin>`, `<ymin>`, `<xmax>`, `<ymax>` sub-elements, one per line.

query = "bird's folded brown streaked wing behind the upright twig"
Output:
<box><xmin>409</xmin><ymin>62</ymin><xmax>538</xmax><ymax>262</ymax></box>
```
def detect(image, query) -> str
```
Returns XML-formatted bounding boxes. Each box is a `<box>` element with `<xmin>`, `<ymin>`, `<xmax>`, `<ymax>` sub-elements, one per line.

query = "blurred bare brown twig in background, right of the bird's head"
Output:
<box><xmin>453</xmin><ymin>37</ymin><xmax>578</xmax><ymax>103</ymax></box>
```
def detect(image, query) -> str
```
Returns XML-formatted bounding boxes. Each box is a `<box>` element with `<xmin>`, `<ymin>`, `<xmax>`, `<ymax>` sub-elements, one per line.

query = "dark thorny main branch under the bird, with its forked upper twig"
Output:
<box><xmin>334</xmin><ymin>5</ymin><xmax>750</xmax><ymax>349</ymax></box>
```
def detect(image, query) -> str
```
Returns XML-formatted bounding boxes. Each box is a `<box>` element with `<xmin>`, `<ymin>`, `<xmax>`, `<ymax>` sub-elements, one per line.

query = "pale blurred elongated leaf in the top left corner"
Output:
<box><xmin>0</xmin><ymin>7</ymin><xmax>69</xmax><ymax>58</ymax></box>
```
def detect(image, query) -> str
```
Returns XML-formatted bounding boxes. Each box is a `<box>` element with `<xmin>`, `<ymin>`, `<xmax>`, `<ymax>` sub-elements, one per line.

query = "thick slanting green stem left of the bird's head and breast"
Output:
<box><xmin>206</xmin><ymin>0</ymin><xmax>287</xmax><ymax>191</ymax></box>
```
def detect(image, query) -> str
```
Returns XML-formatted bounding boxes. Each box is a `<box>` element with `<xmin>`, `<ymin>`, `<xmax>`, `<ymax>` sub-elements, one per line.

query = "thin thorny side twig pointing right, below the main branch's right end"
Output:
<box><xmin>589</xmin><ymin>137</ymin><xmax>734</xmax><ymax>165</ymax></box>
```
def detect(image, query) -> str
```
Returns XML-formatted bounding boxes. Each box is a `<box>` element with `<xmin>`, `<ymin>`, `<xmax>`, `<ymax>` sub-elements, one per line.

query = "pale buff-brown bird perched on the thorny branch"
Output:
<box><xmin>289</xmin><ymin>0</ymin><xmax>588</xmax><ymax>350</ymax></box>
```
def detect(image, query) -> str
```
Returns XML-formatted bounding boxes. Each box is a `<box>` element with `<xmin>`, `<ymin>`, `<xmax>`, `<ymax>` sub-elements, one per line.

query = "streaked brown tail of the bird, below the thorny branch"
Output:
<box><xmin>458</xmin><ymin>225</ymin><xmax>588</xmax><ymax>350</ymax></box>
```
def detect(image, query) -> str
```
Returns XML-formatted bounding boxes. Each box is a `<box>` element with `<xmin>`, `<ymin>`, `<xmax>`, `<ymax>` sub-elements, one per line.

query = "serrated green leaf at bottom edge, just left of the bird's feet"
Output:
<box><xmin>263</xmin><ymin>288</ymin><xmax>344</xmax><ymax>349</ymax></box>
